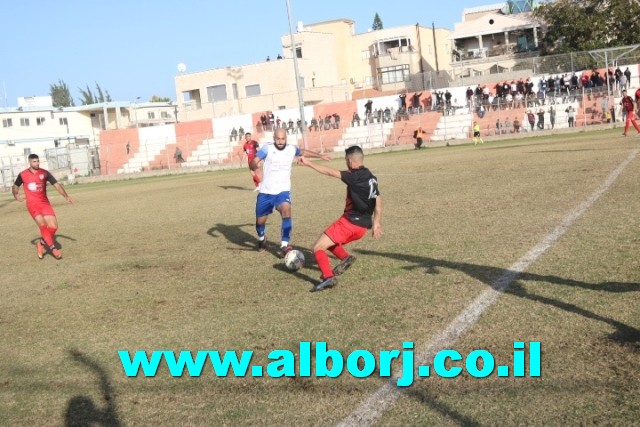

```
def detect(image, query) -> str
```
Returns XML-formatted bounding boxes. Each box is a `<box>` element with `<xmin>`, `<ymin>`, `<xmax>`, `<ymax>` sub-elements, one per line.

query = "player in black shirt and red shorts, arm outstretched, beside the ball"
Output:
<box><xmin>300</xmin><ymin>145</ymin><xmax>382</xmax><ymax>292</ymax></box>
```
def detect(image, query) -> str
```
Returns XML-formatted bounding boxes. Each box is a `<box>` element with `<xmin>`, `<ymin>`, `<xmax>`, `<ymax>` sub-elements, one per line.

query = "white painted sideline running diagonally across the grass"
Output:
<box><xmin>338</xmin><ymin>149</ymin><xmax>640</xmax><ymax>426</ymax></box>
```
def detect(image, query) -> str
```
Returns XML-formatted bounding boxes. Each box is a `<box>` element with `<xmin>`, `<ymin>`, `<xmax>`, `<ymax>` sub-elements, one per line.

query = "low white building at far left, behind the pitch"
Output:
<box><xmin>0</xmin><ymin>96</ymin><xmax>177</xmax><ymax>184</ymax></box>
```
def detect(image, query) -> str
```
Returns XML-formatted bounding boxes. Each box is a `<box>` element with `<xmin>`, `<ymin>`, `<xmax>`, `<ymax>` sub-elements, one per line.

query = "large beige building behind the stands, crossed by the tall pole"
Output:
<box><xmin>175</xmin><ymin>19</ymin><xmax>453</xmax><ymax>120</ymax></box>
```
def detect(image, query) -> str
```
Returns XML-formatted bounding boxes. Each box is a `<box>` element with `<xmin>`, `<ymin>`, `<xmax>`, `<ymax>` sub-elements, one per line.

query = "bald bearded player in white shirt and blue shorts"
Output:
<box><xmin>250</xmin><ymin>128</ymin><xmax>331</xmax><ymax>256</ymax></box>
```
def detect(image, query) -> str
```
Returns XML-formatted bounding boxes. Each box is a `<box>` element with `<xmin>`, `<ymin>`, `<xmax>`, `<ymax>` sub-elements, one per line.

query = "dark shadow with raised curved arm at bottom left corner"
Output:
<box><xmin>64</xmin><ymin>350</ymin><xmax>122</xmax><ymax>427</ymax></box>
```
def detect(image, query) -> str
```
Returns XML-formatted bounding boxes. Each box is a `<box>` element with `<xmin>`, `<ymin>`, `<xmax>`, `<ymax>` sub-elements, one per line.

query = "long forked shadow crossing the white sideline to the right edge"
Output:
<box><xmin>357</xmin><ymin>250</ymin><xmax>640</xmax><ymax>351</ymax></box>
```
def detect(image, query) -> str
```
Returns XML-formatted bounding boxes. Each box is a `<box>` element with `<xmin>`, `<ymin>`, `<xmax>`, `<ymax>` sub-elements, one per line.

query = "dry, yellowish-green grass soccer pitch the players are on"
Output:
<box><xmin>0</xmin><ymin>130</ymin><xmax>640</xmax><ymax>426</ymax></box>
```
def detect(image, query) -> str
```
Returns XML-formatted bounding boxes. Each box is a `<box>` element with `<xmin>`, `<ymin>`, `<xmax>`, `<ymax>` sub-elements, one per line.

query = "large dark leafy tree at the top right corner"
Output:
<box><xmin>534</xmin><ymin>0</ymin><xmax>640</xmax><ymax>54</ymax></box>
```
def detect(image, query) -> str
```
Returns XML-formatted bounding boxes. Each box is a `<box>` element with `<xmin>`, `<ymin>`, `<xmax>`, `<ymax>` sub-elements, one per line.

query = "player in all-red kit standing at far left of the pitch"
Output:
<box><xmin>11</xmin><ymin>154</ymin><xmax>73</xmax><ymax>259</ymax></box>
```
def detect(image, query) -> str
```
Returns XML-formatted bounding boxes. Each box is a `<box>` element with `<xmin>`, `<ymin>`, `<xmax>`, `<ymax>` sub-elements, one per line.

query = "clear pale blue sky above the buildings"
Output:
<box><xmin>0</xmin><ymin>0</ymin><xmax>492</xmax><ymax>107</ymax></box>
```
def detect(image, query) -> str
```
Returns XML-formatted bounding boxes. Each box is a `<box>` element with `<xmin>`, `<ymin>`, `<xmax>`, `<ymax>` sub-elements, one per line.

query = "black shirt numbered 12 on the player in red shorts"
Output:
<box><xmin>340</xmin><ymin>167</ymin><xmax>380</xmax><ymax>228</ymax></box>
